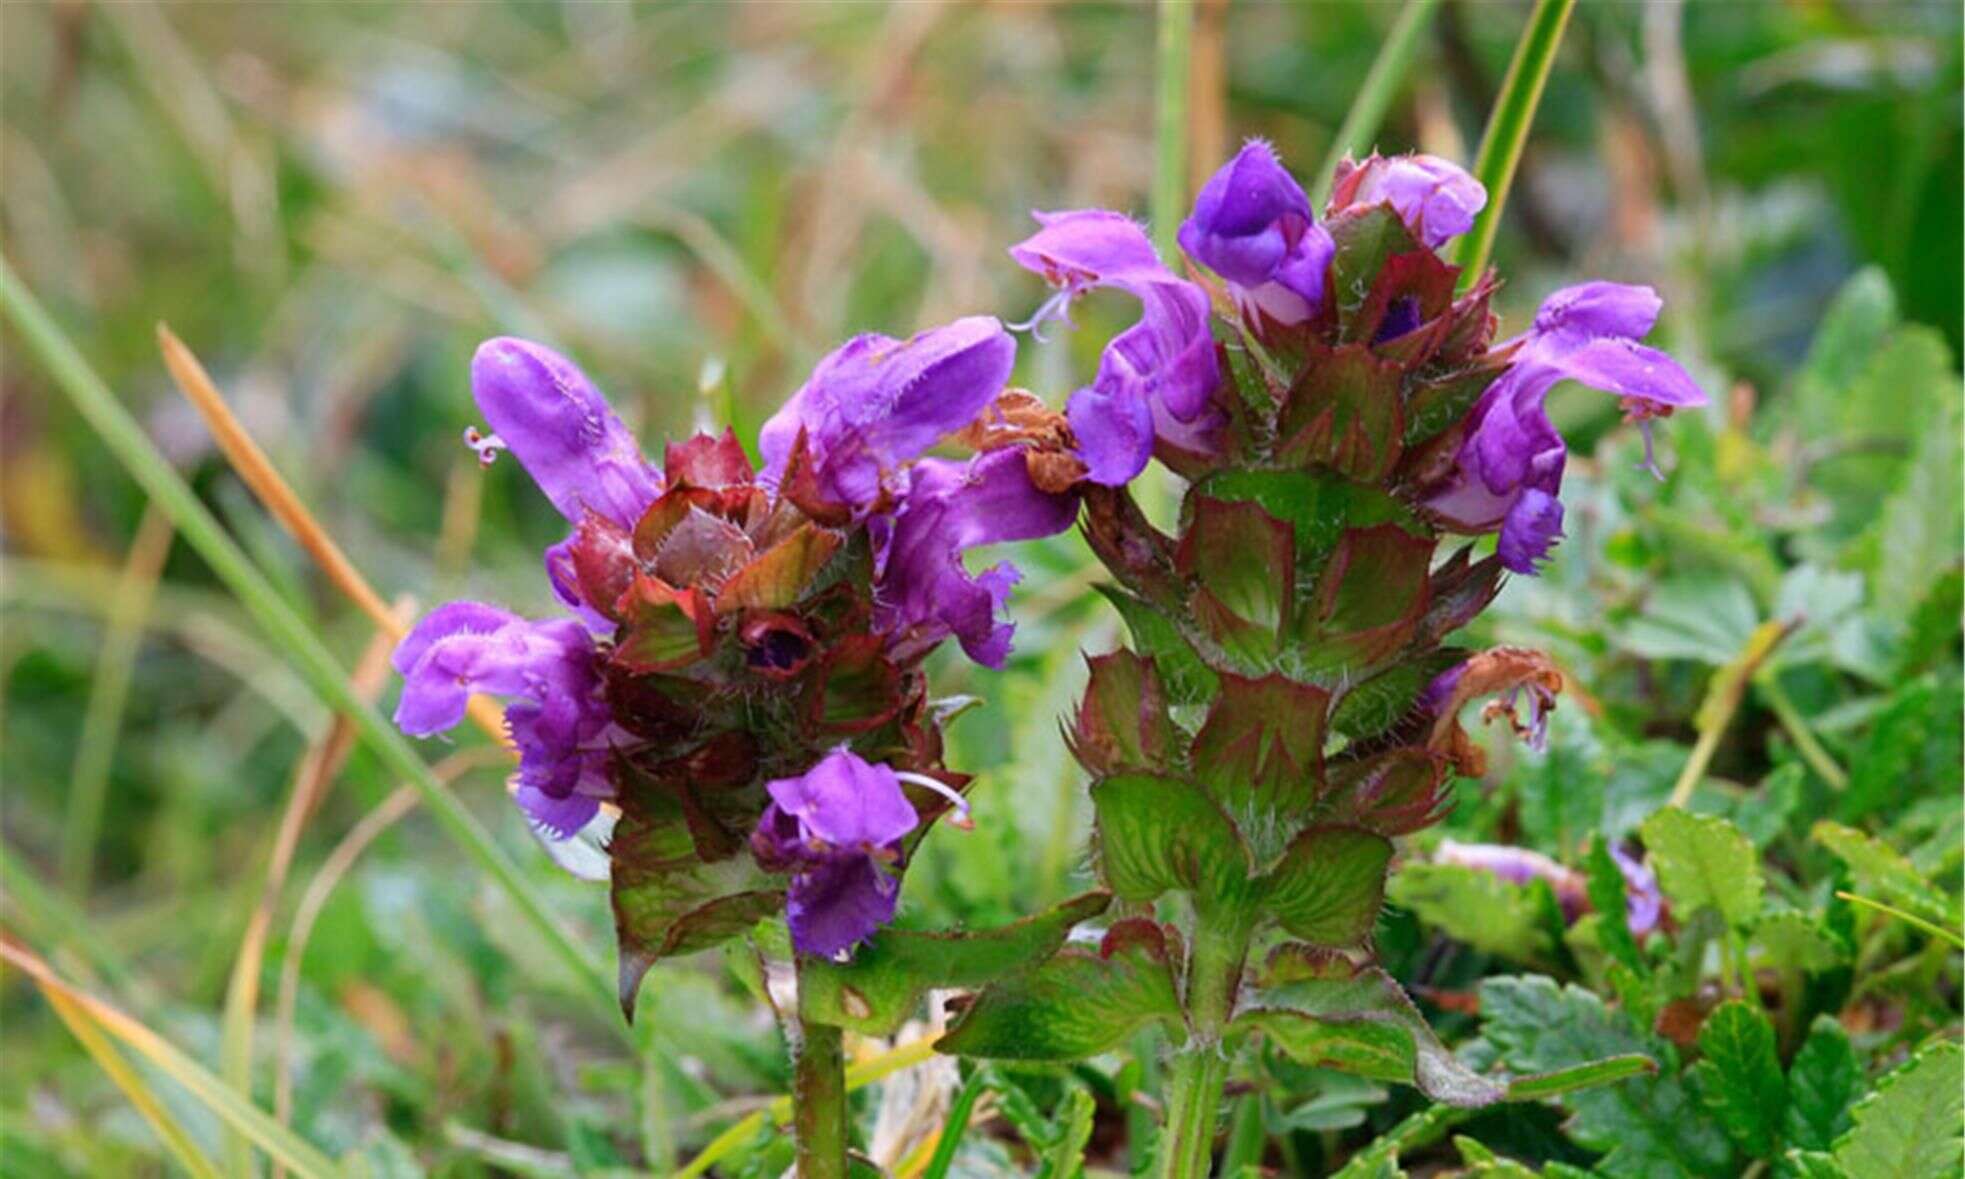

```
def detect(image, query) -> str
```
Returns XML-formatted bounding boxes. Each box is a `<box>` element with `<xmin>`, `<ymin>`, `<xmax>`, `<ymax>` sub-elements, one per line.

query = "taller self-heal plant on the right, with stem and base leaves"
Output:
<box><xmin>943</xmin><ymin>143</ymin><xmax>1704</xmax><ymax>1175</ymax></box>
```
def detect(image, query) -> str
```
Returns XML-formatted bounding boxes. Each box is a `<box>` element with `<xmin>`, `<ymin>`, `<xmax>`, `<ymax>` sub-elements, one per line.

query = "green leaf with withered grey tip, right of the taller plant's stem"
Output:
<box><xmin>1230</xmin><ymin>967</ymin><xmax>1507</xmax><ymax>1106</ymax></box>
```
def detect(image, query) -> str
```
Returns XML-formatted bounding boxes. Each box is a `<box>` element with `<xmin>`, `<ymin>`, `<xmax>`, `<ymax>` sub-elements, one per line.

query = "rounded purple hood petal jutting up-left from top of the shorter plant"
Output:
<box><xmin>472</xmin><ymin>336</ymin><xmax>662</xmax><ymax>529</ymax></box>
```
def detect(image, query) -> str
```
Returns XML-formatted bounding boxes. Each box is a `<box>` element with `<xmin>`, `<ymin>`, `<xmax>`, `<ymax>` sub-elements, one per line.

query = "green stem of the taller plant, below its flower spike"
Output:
<box><xmin>1157</xmin><ymin>912</ymin><xmax>1250</xmax><ymax>1179</ymax></box>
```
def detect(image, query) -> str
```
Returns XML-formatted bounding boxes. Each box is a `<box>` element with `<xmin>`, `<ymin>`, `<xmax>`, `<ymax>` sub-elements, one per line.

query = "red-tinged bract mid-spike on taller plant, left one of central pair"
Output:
<box><xmin>1175</xmin><ymin>495</ymin><xmax>1297</xmax><ymax>637</ymax></box>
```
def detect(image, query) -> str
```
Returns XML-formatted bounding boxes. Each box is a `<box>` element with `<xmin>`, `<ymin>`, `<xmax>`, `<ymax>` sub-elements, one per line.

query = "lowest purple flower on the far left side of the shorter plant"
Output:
<box><xmin>391</xmin><ymin>601</ymin><xmax>613</xmax><ymax>839</ymax></box>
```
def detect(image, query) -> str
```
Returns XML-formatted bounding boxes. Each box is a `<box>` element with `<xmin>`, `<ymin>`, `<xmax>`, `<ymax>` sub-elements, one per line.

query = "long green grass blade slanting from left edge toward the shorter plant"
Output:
<box><xmin>0</xmin><ymin>259</ymin><xmax>625</xmax><ymax>1036</ymax></box>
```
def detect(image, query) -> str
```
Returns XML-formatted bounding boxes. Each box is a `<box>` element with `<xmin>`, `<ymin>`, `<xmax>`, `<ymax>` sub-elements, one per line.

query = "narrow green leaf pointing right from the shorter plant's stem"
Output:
<box><xmin>798</xmin><ymin>892</ymin><xmax>1112</xmax><ymax>1036</ymax></box>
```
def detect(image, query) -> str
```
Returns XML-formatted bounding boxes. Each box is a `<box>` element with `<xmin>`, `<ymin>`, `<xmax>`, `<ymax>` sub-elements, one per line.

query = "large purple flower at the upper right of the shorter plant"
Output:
<box><xmin>758</xmin><ymin>316</ymin><xmax>1016</xmax><ymax>511</ymax></box>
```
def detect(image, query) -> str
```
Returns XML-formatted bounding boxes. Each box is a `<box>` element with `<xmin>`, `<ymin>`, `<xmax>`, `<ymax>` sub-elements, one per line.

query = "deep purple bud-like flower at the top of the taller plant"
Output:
<box><xmin>1181</xmin><ymin>140</ymin><xmax>1336</xmax><ymax>326</ymax></box>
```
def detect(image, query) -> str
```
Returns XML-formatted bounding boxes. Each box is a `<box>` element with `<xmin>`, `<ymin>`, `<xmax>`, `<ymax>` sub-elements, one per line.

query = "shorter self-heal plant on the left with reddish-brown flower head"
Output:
<box><xmin>395</xmin><ymin>318</ymin><xmax>1093</xmax><ymax>1175</ymax></box>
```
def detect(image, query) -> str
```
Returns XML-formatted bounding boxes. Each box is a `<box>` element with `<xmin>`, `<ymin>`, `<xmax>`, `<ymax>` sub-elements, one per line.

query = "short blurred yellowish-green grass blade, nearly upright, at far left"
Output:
<box><xmin>61</xmin><ymin>505</ymin><xmax>171</xmax><ymax>898</ymax></box>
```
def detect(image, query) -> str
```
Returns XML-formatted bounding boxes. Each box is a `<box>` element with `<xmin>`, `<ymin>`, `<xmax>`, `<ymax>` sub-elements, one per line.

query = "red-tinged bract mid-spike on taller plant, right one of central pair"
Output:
<box><xmin>1299</xmin><ymin>525</ymin><xmax>1432</xmax><ymax>672</ymax></box>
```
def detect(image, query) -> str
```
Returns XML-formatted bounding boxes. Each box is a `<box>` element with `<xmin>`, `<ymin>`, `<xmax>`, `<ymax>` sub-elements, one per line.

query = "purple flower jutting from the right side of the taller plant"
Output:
<box><xmin>1427</xmin><ymin>283</ymin><xmax>1706</xmax><ymax>574</ymax></box>
